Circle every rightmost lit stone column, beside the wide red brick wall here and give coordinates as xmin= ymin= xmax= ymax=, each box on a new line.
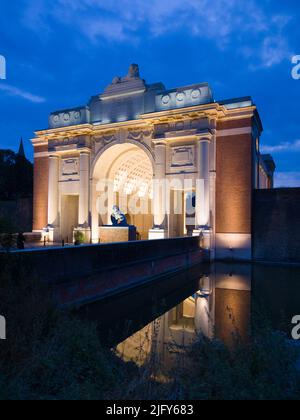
xmin=194 ymin=138 xmax=210 ymax=248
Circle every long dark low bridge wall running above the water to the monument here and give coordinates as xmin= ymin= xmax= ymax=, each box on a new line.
xmin=0 ymin=237 xmax=204 ymax=304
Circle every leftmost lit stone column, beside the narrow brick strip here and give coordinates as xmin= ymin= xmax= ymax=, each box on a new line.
xmin=48 ymin=155 xmax=59 ymax=228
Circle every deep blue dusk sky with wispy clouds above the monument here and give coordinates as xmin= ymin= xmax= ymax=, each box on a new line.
xmin=0 ymin=0 xmax=300 ymax=186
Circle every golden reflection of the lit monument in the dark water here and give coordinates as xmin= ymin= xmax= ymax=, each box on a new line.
xmin=117 ymin=264 xmax=251 ymax=368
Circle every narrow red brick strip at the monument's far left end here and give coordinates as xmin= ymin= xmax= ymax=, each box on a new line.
xmin=33 ymin=157 xmax=49 ymax=230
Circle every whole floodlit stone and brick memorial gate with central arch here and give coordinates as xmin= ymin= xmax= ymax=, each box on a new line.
xmin=33 ymin=65 xmax=274 ymax=258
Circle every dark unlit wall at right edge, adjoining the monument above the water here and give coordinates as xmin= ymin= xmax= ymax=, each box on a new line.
xmin=253 ymin=188 xmax=300 ymax=262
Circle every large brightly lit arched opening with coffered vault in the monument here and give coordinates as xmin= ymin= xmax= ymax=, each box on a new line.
xmin=92 ymin=143 xmax=153 ymax=242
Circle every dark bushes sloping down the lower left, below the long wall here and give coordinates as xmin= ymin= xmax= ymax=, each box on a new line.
xmin=0 ymin=255 xmax=131 ymax=400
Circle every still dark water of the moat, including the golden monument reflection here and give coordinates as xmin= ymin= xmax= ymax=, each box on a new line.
xmin=79 ymin=263 xmax=300 ymax=366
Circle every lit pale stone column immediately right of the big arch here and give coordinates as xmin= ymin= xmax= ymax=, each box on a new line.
xmin=149 ymin=142 xmax=167 ymax=239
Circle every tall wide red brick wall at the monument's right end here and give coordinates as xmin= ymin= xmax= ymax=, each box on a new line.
xmin=216 ymin=120 xmax=252 ymax=234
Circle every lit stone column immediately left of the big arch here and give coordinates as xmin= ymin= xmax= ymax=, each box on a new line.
xmin=78 ymin=152 xmax=90 ymax=228
